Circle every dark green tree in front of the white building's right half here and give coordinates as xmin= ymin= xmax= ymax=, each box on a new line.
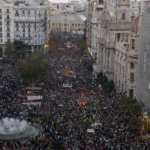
xmin=14 ymin=40 xmax=28 ymax=59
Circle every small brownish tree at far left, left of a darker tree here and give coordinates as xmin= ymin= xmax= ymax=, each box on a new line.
xmin=4 ymin=40 xmax=14 ymax=57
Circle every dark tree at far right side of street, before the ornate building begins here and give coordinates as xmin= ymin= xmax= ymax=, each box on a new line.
xmin=75 ymin=38 xmax=87 ymax=55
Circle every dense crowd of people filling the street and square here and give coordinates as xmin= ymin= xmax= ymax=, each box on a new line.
xmin=0 ymin=33 xmax=150 ymax=150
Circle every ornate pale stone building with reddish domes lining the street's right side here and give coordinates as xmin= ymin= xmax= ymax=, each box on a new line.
xmin=91 ymin=0 xmax=144 ymax=98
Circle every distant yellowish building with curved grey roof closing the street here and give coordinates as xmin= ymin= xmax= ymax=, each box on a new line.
xmin=52 ymin=12 xmax=86 ymax=32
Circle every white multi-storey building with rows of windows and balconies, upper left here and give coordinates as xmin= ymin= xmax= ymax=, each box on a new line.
xmin=0 ymin=0 xmax=51 ymax=55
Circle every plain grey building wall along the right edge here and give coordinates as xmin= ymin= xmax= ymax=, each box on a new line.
xmin=137 ymin=1 xmax=150 ymax=111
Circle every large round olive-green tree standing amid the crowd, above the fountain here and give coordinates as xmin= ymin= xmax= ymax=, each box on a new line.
xmin=16 ymin=53 xmax=49 ymax=82
